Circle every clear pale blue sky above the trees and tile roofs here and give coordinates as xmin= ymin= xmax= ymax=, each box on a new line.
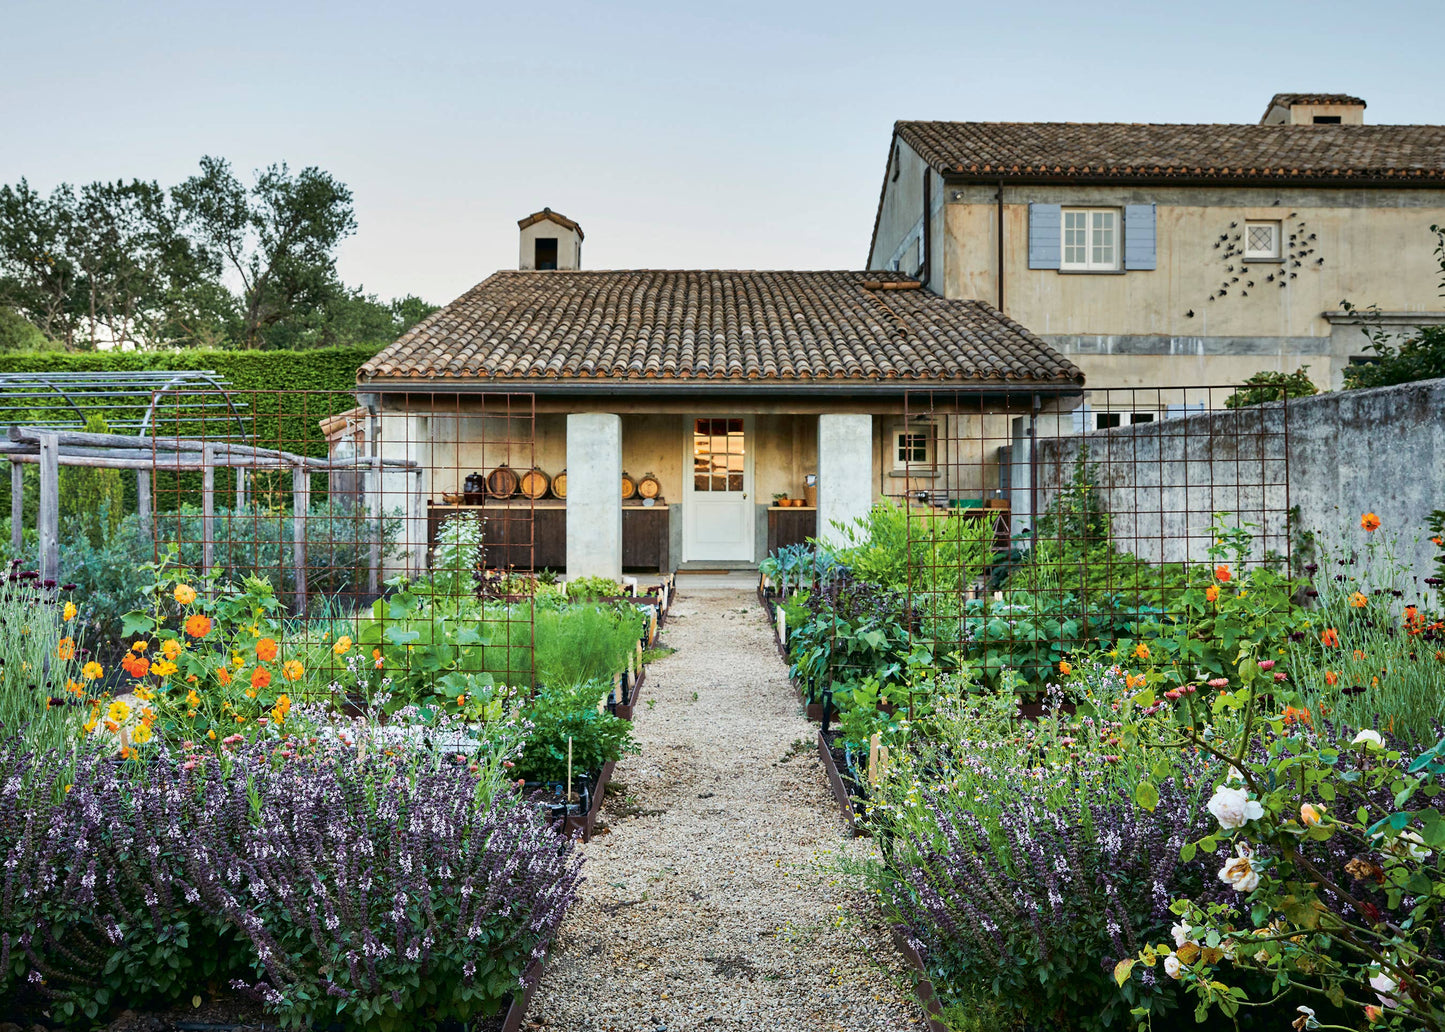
xmin=0 ymin=0 xmax=1445 ymax=304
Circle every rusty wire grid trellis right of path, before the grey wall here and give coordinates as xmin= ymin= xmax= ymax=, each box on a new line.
xmin=881 ymin=386 xmax=1290 ymax=692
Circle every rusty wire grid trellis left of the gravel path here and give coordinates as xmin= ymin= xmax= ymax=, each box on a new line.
xmin=150 ymin=390 xmax=535 ymax=705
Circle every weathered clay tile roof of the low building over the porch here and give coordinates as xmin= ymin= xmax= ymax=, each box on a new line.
xmin=357 ymin=270 xmax=1082 ymax=387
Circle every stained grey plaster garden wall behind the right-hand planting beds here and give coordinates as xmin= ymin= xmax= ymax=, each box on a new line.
xmin=1039 ymin=380 xmax=1445 ymax=578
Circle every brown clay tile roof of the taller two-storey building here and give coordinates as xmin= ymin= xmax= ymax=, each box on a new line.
xmin=894 ymin=121 xmax=1445 ymax=186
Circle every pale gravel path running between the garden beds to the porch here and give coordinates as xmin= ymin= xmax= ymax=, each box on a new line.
xmin=527 ymin=578 xmax=922 ymax=1032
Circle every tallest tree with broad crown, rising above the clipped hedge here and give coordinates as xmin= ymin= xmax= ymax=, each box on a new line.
xmin=172 ymin=156 xmax=355 ymax=348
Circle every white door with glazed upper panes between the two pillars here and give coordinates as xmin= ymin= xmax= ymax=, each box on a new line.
xmin=682 ymin=416 xmax=756 ymax=562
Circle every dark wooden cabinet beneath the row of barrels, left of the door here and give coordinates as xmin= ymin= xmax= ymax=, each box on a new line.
xmin=426 ymin=499 xmax=672 ymax=572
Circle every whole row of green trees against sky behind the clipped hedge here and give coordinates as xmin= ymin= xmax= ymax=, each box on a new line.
xmin=0 ymin=156 xmax=435 ymax=350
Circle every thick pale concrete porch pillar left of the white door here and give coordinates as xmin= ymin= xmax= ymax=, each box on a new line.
xmin=566 ymin=412 xmax=623 ymax=578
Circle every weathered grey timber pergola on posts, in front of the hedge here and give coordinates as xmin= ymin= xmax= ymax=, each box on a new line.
xmin=0 ymin=426 xmax=423 ymax=611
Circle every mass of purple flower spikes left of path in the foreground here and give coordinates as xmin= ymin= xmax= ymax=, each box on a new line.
xmin=0 ymin=741 xmax=581 ymax=1028
